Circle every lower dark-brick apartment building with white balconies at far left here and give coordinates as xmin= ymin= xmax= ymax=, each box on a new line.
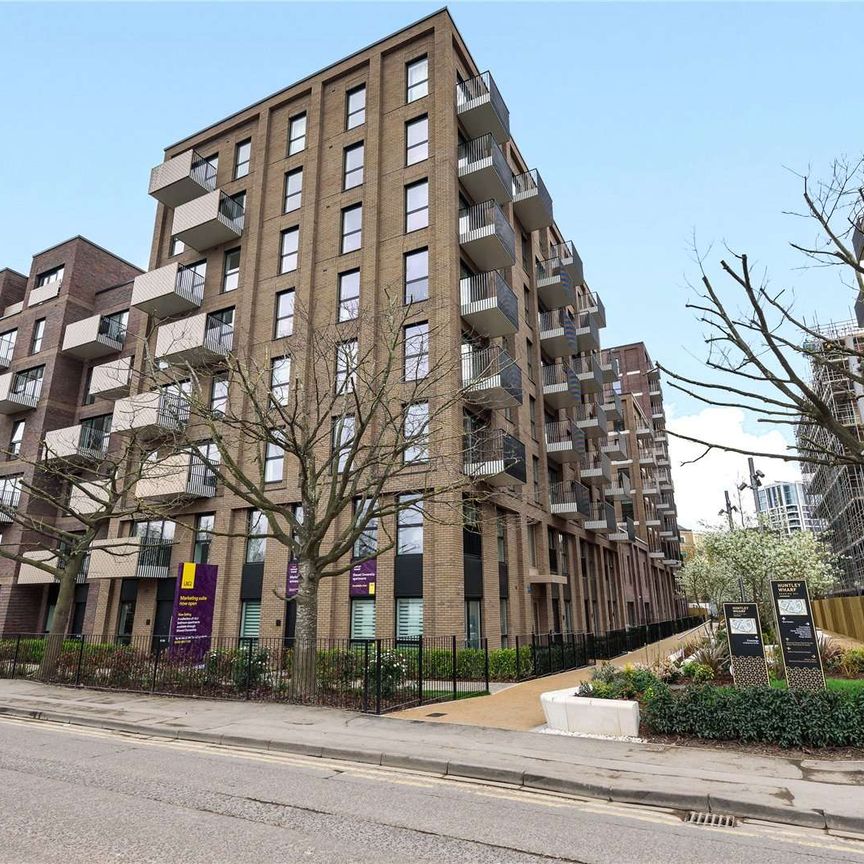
xmin=0 ymin=237 xmax=146 ymax=633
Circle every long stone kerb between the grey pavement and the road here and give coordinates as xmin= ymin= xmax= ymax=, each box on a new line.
xmin=0 ymin=705 xmax=852 ymax=833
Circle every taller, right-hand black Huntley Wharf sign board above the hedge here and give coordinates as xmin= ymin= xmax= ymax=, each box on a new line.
xmin=771 ymin=579 xmax=825 ymax=690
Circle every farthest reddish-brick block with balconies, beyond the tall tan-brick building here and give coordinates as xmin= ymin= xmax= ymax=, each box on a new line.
xmin=603 ymin=342 xmax=686 ymax=624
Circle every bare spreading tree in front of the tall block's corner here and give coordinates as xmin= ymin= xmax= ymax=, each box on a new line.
xmin=158 ymin=296 xmax=512 ymax=695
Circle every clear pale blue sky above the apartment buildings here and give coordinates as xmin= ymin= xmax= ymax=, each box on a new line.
xmin=0 ymin=3 xmax=864 ymax=520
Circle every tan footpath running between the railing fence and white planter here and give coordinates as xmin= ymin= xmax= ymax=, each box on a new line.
xmin=398 ymin=626 xmax=704 ymax=731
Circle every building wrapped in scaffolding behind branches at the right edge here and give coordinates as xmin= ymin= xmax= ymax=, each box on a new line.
xmin=798 ymin=320 xmax=864 ymax=589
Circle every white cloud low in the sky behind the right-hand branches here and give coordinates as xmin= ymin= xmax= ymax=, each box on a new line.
xmin=666 ymin=404 xmax=801 ymax=528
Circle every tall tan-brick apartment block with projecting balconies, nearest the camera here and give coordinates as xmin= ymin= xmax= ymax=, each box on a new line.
xmin=3 ymin=10 xmax=680 ymax=646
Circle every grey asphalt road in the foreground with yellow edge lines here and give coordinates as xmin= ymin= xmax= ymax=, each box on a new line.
xmin=0 ymin=718 xmax=864 ymax=864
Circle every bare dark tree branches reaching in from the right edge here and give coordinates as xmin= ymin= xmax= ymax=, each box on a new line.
xmin=659 ymin=160 xmax=864 ymax=465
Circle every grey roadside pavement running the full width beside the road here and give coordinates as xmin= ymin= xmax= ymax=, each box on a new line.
xmin=0 ymin=680 xmax=864 ymax=839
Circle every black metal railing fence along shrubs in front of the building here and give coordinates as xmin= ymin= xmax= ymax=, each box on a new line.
xmin=0 ymin=618 xmax=702 ymax=714
